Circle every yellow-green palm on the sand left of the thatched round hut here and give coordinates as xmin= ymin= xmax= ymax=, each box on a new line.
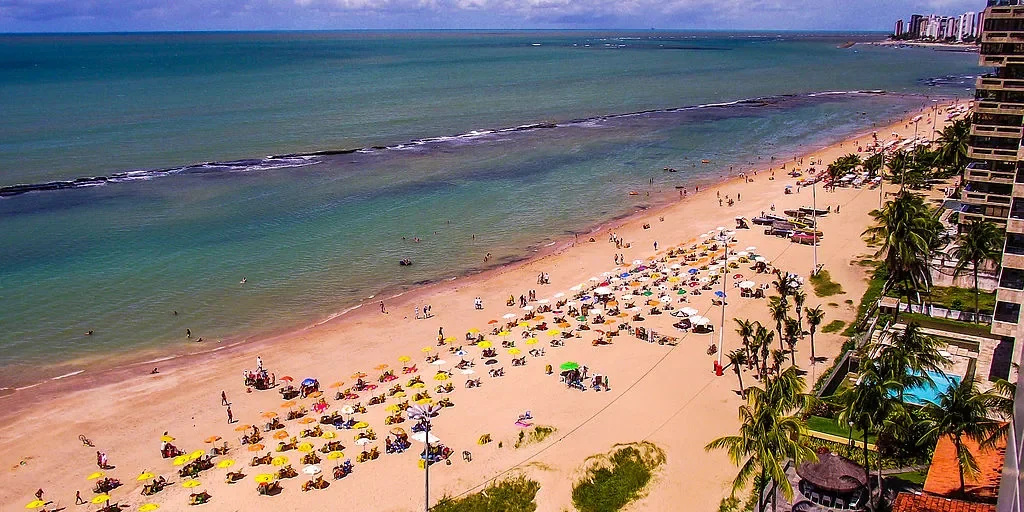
xmin=705 ymin=369 xmax=815 ymax=512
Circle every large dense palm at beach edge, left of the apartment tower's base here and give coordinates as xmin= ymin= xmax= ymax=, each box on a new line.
xmin=863 ymin=191 xmax=942 ymax=299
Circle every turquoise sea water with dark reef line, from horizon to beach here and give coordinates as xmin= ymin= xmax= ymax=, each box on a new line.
xmin=0 ymin=32 xmax=980 ymax=388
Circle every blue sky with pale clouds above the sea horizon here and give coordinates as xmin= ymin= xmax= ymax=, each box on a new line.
xmin=0 ymin=0 xmax=985 ymax=32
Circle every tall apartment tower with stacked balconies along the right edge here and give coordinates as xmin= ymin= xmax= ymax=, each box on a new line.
xmin=974 ymin=0 xmax=1024 ymax=512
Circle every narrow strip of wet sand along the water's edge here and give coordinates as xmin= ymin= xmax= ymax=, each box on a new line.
xmin=0 ymin=95 xmax=954 ymax=415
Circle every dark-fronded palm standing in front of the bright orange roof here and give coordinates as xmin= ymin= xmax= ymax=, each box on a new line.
xmin=921 ymin=379 xmax=996 ymax=494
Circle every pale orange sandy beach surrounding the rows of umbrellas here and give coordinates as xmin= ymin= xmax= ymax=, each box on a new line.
xmin=0 ymin=101 xmax=958 ymax=511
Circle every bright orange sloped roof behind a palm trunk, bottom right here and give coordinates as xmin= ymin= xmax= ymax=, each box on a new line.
xmin=925 ymin=436 xmax=1007 ymax=499
